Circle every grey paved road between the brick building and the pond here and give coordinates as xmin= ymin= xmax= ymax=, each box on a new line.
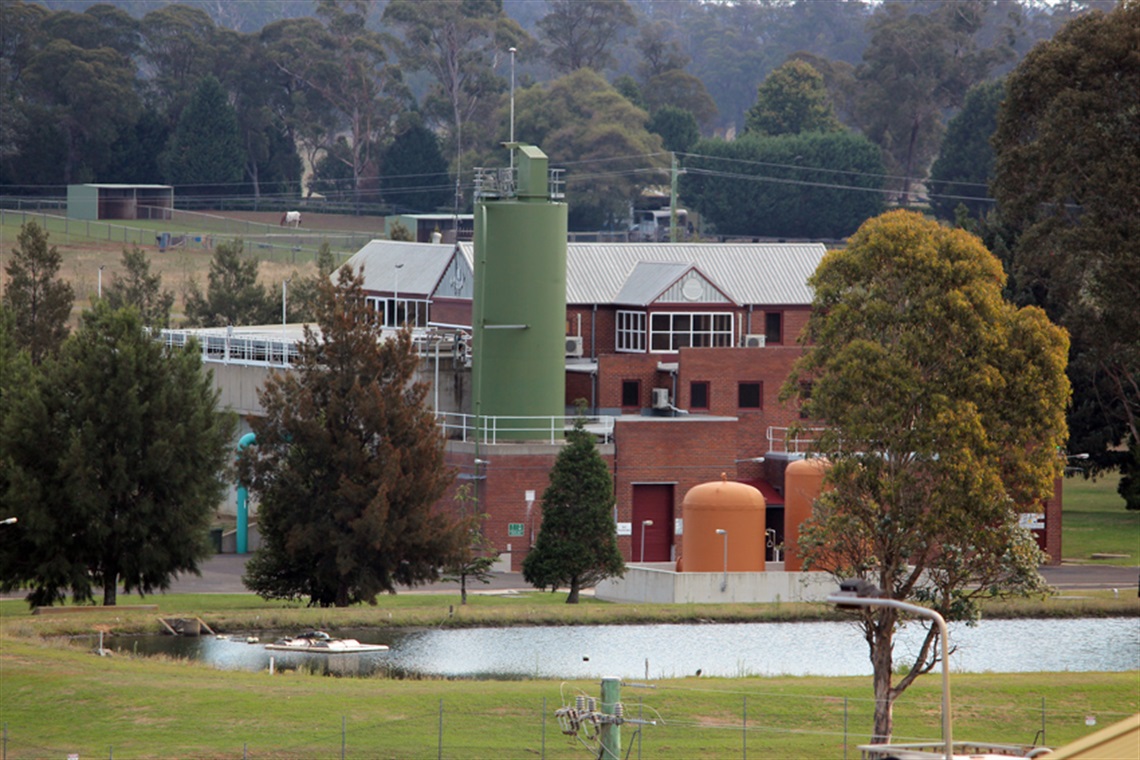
xmin=171 ymin=554 xmax=1140 ymax=594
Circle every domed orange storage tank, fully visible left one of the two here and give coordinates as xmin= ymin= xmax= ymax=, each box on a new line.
xmin=678 ymin=479 xmax=766 ymax=573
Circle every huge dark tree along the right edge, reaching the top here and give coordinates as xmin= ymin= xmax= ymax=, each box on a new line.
xmin=992 ymin=1 xmax=1140 ymax=508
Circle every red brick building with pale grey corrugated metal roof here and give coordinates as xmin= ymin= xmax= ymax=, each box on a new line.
xmin=330 ymin=240 xmax=1060 ymax=570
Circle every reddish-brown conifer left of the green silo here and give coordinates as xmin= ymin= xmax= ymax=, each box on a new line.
xmin=241 ymin=268 xmax=470 ymax=607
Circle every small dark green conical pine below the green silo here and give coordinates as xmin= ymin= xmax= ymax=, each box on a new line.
xmin=522 ymin=416 xmax=625 ymax=604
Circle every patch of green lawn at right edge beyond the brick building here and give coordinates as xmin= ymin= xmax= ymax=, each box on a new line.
xmin=1061 ymin=474 xmax=1140 ymax=565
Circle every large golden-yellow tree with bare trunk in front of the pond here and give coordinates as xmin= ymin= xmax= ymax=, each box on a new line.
xmin=782 ymin=211 xmax=1069 ymax=742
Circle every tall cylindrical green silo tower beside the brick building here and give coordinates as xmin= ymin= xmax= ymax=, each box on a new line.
xmin=472 ymin=145 xmax=567 ymax=440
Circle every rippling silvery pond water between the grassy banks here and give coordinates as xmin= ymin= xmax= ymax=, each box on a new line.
xmin=105 ymin=618 xmax=1140 ymax=679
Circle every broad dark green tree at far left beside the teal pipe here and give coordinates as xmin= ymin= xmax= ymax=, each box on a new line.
xmin=0 ymin=301 xmax=234 ymax=606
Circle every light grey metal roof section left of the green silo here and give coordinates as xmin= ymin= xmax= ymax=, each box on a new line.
xmin=344 ymin=240 xmax=455 ymax=299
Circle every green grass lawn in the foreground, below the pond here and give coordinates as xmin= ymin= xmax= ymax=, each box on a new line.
xmin=0 ymin=637 xmax=1140 ymax=760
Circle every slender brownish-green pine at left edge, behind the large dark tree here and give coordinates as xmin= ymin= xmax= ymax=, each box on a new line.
xmin=3 ymin=222 xmax=75 ymax=365
